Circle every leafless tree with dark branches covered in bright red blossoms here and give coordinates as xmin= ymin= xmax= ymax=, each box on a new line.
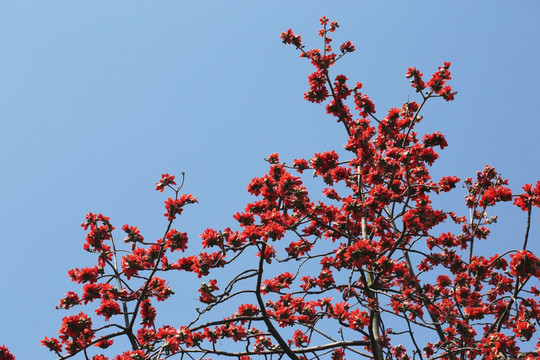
xmin=5 ymin=17 xmax=540 ymax=360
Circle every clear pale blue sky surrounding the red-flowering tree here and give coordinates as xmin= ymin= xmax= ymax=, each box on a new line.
xmin=0 ymin=0 xmax=540 ymax=359
